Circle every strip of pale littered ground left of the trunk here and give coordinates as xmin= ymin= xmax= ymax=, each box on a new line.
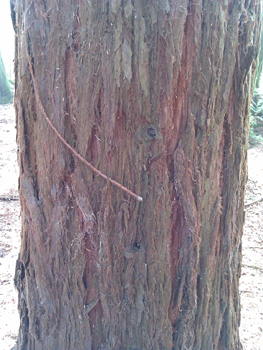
xmin=0 ymin=105 xmax=20 ymax=350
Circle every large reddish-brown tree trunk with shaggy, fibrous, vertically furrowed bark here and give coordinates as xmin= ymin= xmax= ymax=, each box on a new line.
xmin=15 ymin=0 xmax=260 ymax=350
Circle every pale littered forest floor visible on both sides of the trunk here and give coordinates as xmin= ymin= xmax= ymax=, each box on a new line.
xmin=0 ymin=105 xmax=263 ymax=350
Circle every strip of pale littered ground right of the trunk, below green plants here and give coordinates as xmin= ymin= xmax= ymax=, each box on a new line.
xmin=240 ymin=144 xmax=263 ymax=350
